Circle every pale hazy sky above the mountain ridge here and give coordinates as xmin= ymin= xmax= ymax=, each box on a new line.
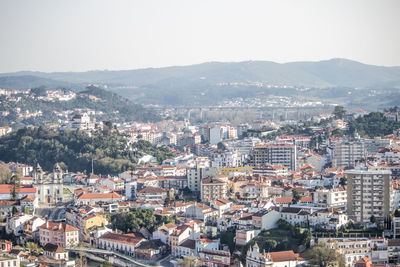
xmin=0 ymin=0 xmax=400 ymax=73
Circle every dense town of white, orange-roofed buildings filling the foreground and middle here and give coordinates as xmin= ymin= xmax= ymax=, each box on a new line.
xmin=0 ymin=104 xmax=400 ymax=267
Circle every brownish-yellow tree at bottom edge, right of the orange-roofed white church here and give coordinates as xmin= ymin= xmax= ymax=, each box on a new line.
xmin=305 ymin=243 xmax=345 ymax=267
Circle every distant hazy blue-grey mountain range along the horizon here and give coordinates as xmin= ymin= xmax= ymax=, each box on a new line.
xmin=0 ymin=59 xmax=400 ymax=104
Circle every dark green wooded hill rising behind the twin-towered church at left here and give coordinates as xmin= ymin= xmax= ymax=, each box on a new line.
xmin=0 ymin=127 xmax=172 ymax=174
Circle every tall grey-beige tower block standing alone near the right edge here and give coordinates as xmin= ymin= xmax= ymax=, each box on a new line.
xmin=345 ymin=167 xmax=393 ymax=222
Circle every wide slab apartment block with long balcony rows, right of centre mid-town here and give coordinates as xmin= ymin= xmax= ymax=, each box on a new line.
xmin=252 ymin=144 xmax=297 ymax=171
